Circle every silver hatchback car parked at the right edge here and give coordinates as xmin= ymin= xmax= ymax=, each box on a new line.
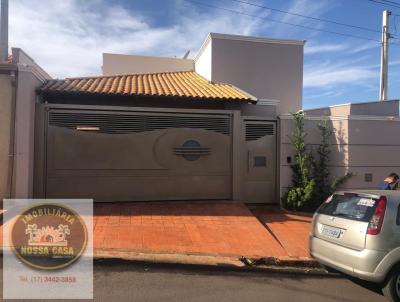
xmin=309 ymin=190 xmax=400 ymax=302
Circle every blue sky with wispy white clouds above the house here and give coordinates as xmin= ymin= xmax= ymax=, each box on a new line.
xmin=10 ymin=0 xmax=400 ymax=108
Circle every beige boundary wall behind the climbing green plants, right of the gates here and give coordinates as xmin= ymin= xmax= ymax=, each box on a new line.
xmin=280 ymin=116 xmax=400 ymax=196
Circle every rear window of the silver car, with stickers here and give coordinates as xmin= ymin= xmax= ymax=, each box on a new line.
xmin=317 ymin=194 xmax=377 ymax=222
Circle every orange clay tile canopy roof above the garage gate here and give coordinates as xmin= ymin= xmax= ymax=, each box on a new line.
xmin=39 ymin=71 xmax=256 ymax=102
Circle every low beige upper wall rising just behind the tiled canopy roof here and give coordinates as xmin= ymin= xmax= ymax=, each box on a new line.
xmin=102 ymin=53 xmax=194 ymax=75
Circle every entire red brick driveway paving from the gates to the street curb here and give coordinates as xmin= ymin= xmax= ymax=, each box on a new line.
xmin=0 ymin=201 xmax=311 ymax=259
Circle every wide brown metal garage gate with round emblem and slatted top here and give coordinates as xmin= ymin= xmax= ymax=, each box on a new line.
xmin=43 ymin=109 xmax=232 ymax=201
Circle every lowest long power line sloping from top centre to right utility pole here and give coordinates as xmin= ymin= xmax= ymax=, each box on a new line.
xmin=183 ymin=0 xmax=380 ymax=43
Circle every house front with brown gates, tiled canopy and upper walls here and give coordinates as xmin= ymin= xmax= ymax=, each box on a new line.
xmin=35 ymin=34 xmax=304 ymax=203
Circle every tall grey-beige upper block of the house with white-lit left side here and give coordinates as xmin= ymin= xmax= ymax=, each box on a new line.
xmin=195 ymin=34 xmax=304 ymax=114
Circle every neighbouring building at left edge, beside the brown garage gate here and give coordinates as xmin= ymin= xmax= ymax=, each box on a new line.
xmin=0 ymin=48 xmax=50 ymax=200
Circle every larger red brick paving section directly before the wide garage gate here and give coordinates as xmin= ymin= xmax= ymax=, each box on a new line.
xmin=94 ymin=202 xmax=287 ymax=257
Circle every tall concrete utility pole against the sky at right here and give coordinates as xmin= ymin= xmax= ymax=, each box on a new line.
xmin=379 ymin=10 xmax=391 ymax=101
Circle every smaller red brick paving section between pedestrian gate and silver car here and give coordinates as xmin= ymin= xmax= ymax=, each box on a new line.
xmin=250 ymin=206 xmax=312 ymax=257
